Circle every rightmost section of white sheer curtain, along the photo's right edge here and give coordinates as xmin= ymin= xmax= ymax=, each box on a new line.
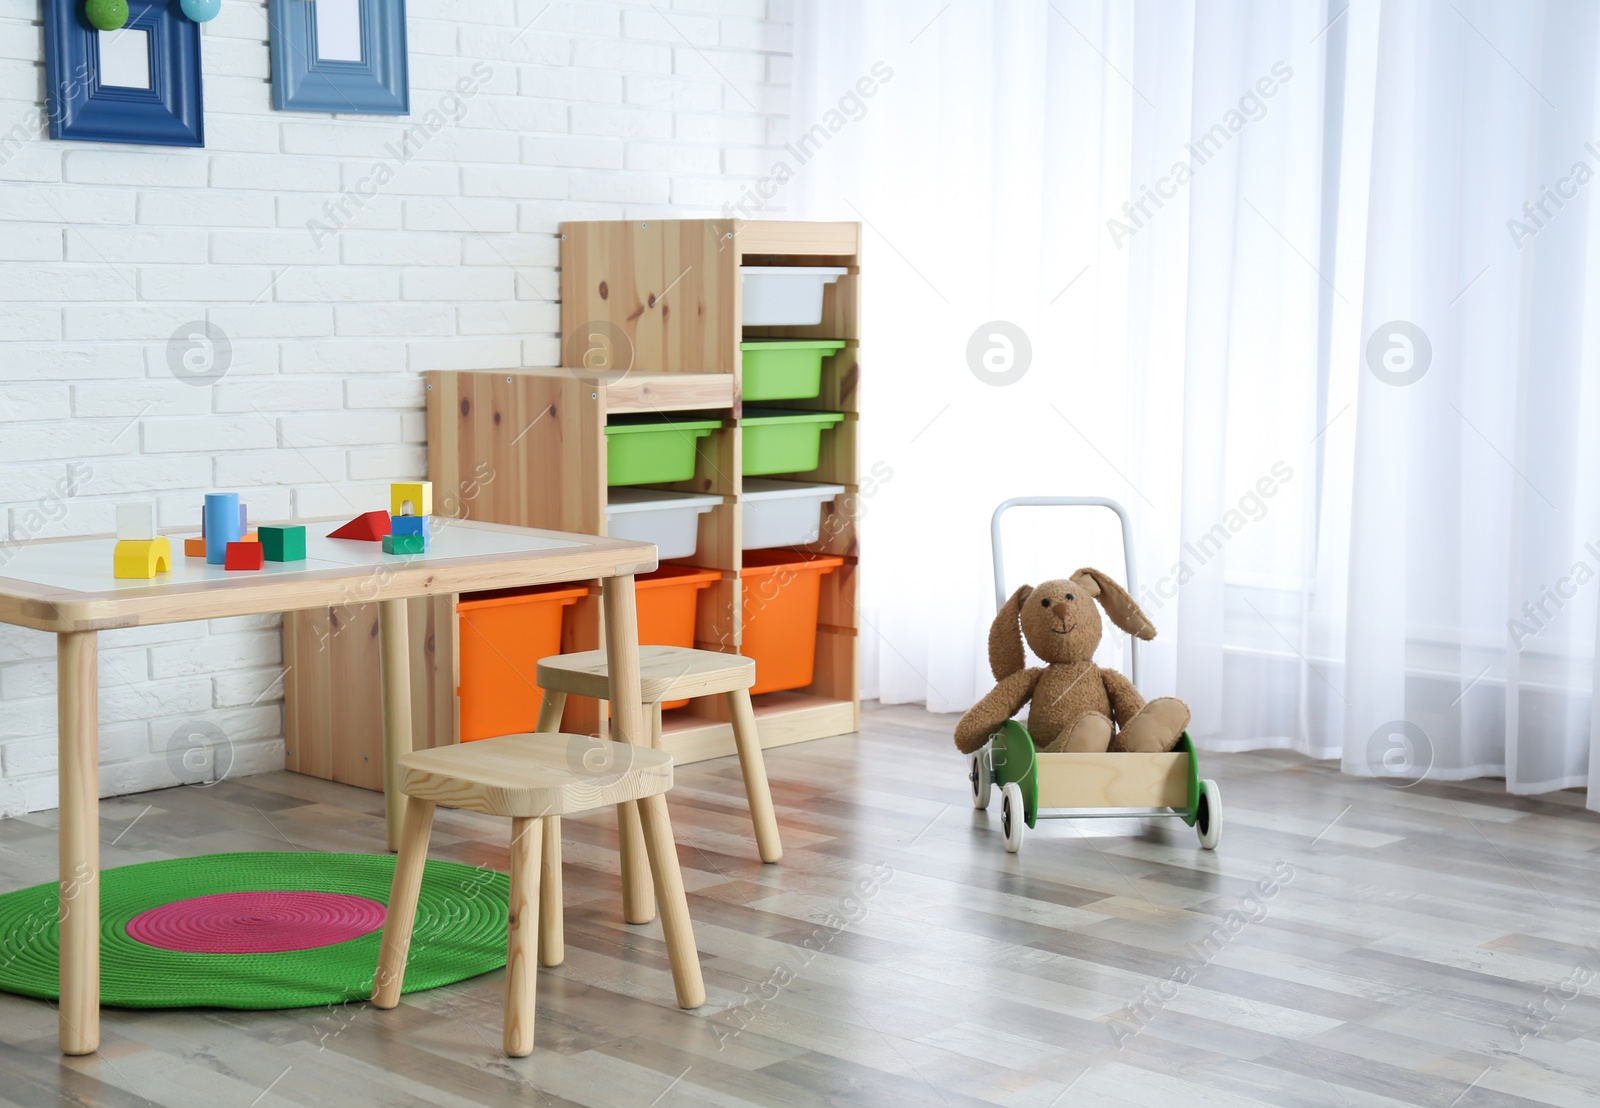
xmin=1342 ymin=3 xmax=1600 ymax=797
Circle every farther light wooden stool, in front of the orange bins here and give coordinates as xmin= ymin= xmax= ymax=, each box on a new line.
xmin=536 ymin=647 xmax=784 ymax=928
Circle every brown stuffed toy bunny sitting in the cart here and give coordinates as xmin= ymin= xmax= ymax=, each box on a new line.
xmin=955 ymin=568 xmax=1189 ymax=754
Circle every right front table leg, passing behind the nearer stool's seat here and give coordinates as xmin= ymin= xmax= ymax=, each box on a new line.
xmin=600 ymin=573 xmax=656 ymax=924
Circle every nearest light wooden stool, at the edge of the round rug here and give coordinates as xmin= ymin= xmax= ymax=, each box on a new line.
xmin=373 ymin=735 xmax=706 ymax=1058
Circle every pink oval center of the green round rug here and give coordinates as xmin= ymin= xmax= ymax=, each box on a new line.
xmin=128 ymin=892 xmax=384 ymax=954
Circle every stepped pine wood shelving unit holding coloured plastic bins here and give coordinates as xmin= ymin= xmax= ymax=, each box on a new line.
xmin=285 ymin=219 xmax=861 ymax=788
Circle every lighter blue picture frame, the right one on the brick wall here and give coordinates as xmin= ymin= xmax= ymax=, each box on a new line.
xmin=267 ymin=0 xmax=411 ymax=115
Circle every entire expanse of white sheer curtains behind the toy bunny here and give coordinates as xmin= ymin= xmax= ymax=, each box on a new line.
xmin=793 ymin=0 xmax=1600 ymax=807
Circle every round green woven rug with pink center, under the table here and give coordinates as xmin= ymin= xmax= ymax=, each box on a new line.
xmin=0 ymin=853 xmax=510 ymax=1009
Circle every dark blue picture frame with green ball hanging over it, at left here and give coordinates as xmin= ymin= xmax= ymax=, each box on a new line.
xmin=45 ymin=0 xmax=205 ymax=146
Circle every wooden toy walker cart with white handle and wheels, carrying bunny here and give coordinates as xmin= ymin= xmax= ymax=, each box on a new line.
xmin=968 ymin=496 xmax=1222 ymax=853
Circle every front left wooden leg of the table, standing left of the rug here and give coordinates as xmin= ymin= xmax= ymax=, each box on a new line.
xmin=56 ymin=631 xmax=99 ymax=1054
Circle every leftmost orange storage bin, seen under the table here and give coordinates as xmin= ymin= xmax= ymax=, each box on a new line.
xmin=456 ymin=584 xmax=589 ymax=743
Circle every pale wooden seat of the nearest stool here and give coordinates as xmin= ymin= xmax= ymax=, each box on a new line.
xmin=400 ymin=733 xmax=672 ymax=817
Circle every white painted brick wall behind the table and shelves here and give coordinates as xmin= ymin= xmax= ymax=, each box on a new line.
xmin=0 ymin=0 xmax=790 ymax=815
